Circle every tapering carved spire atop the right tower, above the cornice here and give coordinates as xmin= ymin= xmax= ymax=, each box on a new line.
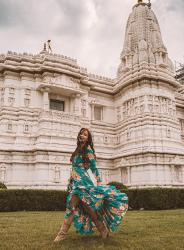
xmin=118 ymin=1 xmax=173 ymax=75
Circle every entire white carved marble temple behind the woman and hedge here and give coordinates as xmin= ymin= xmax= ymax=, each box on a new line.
xmin=0 ymin=1 xmax=184 ymax=189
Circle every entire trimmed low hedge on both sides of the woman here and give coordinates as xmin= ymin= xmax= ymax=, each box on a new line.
xmin=0 ymin=188 xmax=184 ymax=212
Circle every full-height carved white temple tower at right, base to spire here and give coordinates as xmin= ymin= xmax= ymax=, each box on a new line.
xmin=116 ymin=0 xmax=184 ymax=187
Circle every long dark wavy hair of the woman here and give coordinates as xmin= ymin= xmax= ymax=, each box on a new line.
xmin=70 ymin=128 xmax=96 ymax=163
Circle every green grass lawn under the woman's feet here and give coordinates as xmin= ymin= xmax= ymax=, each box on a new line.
xmin=0 ymin=210 xmax=184 ymax=250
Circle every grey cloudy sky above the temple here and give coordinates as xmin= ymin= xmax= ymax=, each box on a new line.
xmin=0 ymin=0 xmax=184 ymax=77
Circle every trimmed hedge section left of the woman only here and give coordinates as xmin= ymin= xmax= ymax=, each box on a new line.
xmin=0 ymin=189 xmax=67 ymax=212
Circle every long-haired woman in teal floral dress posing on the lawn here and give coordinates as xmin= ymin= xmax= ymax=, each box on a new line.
xmin=54 ymin=128 xmax=128 ymax=242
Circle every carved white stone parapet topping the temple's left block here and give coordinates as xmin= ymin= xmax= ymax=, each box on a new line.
xmin=0 ymin=51 xmax=87 ymax=79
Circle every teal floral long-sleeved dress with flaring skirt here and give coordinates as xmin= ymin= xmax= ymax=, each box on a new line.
xmin=64 ymin=146 xmax=128 ymax=234
